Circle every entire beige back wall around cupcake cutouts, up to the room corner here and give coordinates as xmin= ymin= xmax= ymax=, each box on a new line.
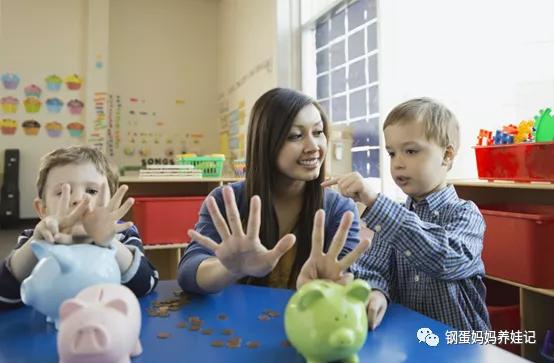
xmin=0 ymin=0 xmax=219 ymax=218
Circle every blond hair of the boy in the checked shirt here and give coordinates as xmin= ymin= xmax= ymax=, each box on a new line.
xmin=383 ymin=97 xmax=460 ymax=155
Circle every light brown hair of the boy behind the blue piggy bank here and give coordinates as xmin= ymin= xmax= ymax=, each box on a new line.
xmin=37 ymin=145 xmax=119 ymax=199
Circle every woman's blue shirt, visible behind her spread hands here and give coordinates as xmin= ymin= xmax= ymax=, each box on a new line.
xmin=177 ymin=181 xmax=360 ymax=294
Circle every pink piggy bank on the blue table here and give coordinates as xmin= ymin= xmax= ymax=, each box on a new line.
xmin=58 ymin=284 xmax=142 ymax=363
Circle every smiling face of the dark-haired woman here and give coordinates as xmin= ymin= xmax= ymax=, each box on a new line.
xmin=277 ymin=104 xmax=327 ymax=181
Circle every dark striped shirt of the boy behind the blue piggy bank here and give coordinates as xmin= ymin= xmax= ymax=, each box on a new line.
xmin=0 ymin=226 xmax=159 ymax=310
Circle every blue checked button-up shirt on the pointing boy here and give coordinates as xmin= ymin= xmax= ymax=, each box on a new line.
xmin=352 ymin=185 xmax=490 ymax=331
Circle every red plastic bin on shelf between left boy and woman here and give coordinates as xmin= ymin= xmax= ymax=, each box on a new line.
xmin=133 ymin=197 xmax=205 ymax=245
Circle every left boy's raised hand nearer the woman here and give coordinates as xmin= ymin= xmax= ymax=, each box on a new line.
xmin=82 ymin=184 xmax=135 ymax=246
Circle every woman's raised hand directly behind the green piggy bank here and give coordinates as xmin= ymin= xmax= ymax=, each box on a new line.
xmin=296 ymin=209 xmax=369 ymax=289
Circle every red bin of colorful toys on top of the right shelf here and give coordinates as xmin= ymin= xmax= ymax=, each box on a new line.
xmin=475 ymin=142 xmax=554 ymax=182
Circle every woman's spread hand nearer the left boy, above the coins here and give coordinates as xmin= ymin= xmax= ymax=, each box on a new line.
xmin=188 ymin=186 xmax=296 ymax=277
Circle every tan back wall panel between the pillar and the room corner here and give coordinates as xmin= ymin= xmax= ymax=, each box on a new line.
xmin=109 ymin=0 xmax=219 ymax=166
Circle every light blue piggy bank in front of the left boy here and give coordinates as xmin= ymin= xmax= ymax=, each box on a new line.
xmin=21 ymin=241 xmax=121 ymax=328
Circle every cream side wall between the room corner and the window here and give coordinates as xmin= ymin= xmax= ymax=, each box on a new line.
xmin=217 ymin=0 xmax=277 ymax=158
